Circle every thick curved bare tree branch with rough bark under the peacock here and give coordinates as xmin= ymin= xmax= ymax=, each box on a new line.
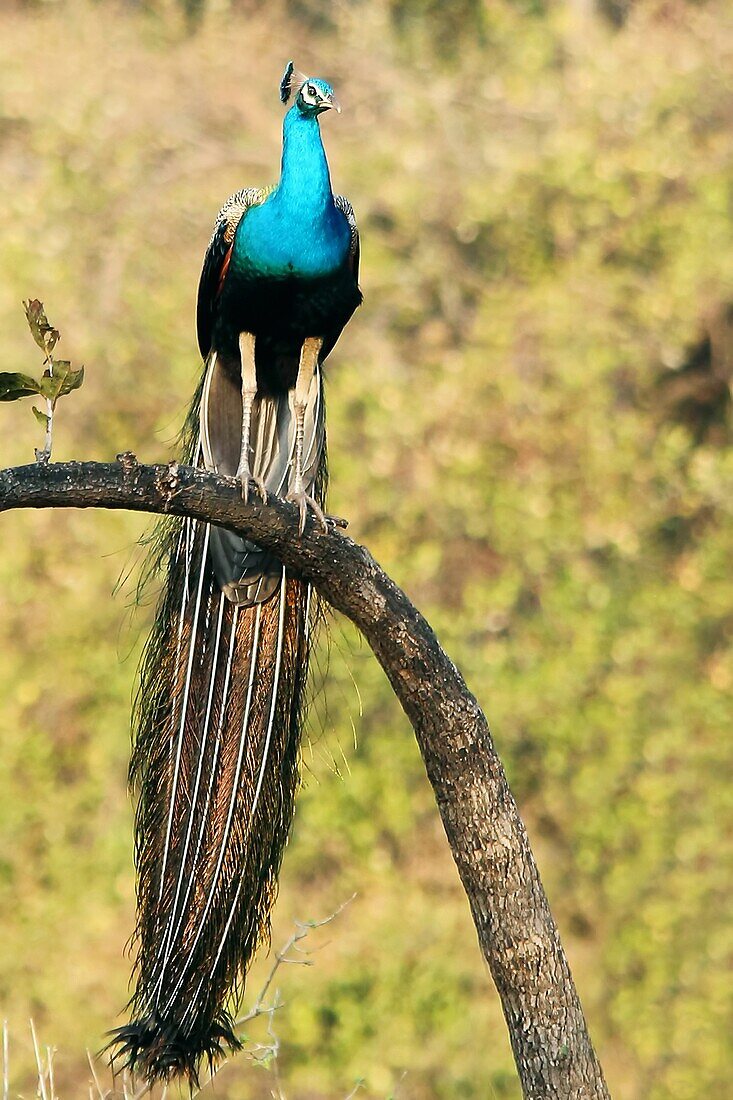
xmin=0 ymin=454 xmax=609 ymax=1100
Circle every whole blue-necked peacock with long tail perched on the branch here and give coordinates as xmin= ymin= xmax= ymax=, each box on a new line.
xmin=111 ymin=62 xmax=361 ymax=1085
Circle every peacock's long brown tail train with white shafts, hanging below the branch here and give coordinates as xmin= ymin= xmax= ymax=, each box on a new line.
xmin=111 ymin=371 xmax=325 ymax=1084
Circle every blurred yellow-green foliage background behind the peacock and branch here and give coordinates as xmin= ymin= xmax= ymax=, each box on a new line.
xmin=0 ymin=0 xmax=733 ymax=1100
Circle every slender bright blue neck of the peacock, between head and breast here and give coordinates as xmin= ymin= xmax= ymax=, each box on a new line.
xmin=272 ymin=103 xmax=333 ymax=212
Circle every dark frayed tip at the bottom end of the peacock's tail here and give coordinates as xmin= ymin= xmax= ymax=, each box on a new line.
xmin=103 ymin=1015 xmax=242 ymax=1088
